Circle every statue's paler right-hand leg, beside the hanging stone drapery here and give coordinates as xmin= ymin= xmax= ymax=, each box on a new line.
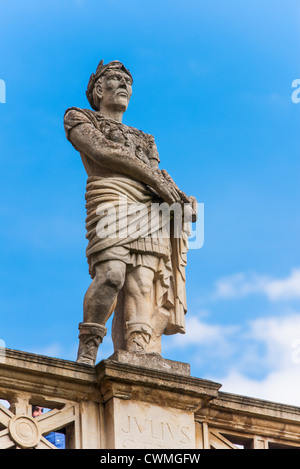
xmin=124 ymin=267 xmax=154 ymax=352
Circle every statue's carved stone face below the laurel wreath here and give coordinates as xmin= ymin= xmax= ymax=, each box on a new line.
xmin=96 ymin=70 xmax=132 ymax=112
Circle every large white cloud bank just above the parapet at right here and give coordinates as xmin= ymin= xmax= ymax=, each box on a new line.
xmin=163 ymin=312 xmax=300 ymax=406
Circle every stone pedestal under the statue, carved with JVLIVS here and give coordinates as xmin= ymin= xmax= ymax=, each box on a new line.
xmin=98 ymin=352 xmax=220 ymax=449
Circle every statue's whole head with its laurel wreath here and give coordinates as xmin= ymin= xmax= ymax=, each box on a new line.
xmin=86 ymin=60 xmax=133 ymax=112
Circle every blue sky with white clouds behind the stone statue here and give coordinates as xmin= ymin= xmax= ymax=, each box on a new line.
xmin=0 ymin=0 xmax=300 ymax=406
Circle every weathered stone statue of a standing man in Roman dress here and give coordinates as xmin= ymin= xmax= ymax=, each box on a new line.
xmin=64 ymin=60 xmax=197 ymax=365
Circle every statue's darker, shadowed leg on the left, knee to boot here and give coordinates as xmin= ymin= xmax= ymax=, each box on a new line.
xmin=77 ymin=260 xmax=126 ymax=365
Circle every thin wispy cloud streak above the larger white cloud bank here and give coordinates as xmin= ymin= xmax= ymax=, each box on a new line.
xmin=214 ymin=269 xmax=300 ymax=301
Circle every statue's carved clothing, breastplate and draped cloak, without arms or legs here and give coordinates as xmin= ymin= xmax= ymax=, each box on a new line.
xmin=64 ymin=108 xmax=189 ymax=334
